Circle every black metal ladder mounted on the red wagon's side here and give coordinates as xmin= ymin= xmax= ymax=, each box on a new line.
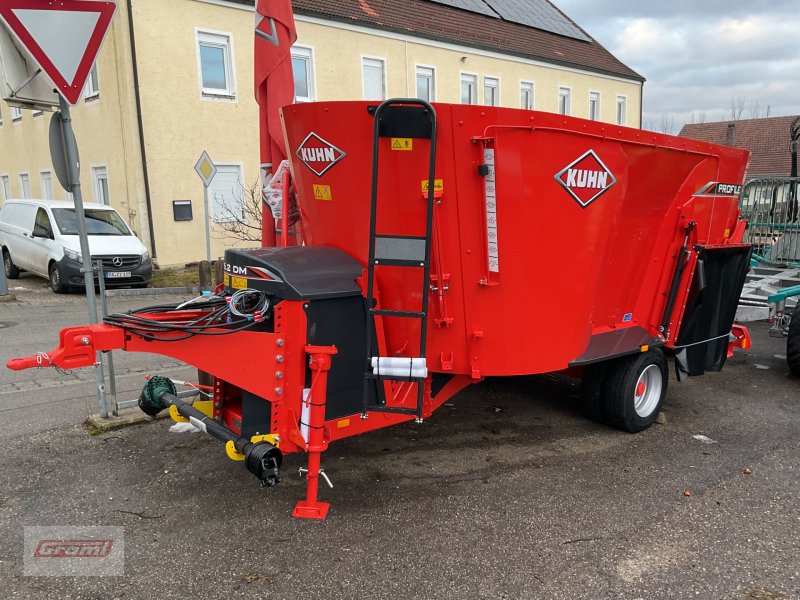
xmin=361 ymin=98 xmax=436 ymax=422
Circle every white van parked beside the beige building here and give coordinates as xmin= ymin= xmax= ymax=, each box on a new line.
xmin=0 ymin=200 xmax=153 ymax=293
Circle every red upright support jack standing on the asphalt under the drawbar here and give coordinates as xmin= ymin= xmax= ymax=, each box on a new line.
xmin=292 ymin=346 xmax=337 ymax=520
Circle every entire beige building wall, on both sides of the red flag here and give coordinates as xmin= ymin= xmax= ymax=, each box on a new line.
xmin=0 ymin=0 xmax=641 ymax=265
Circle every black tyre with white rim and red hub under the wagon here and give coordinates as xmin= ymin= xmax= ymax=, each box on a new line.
xmin=603 ymin=349 xmax=668 ymax=433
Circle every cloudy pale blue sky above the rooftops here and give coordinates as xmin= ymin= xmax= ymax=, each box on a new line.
xmin=553 ymin=0 xmax=800 ymax=134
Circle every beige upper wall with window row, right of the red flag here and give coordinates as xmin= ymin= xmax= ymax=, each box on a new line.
xmin=296 ymin=16 xmax=642 ymax=127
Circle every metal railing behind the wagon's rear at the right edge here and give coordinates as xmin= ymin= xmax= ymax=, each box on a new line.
xmin=739 ymin=177 xmax=800 ymax=266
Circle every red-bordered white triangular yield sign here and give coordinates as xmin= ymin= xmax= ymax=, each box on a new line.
xmin=0 ymin=0 xmax=117 ymax=104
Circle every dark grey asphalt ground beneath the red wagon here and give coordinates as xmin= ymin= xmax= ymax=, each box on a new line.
xmin=0 ymin=288 xmax=800 ymax=600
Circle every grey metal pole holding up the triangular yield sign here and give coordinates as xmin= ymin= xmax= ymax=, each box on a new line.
xmin=58 ymin=94 xmax=108 ymax=419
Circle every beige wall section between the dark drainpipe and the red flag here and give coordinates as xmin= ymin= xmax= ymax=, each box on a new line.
xmin=134 ymin=0 xmax=259 ymax=264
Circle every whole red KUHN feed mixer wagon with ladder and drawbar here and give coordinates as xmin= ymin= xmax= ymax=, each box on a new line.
xmin=8 ymin=99 xmax=751 ymax=518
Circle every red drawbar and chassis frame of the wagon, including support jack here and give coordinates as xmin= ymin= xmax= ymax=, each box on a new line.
xmin=7 ymin=300 xmax=480 ymax=519
